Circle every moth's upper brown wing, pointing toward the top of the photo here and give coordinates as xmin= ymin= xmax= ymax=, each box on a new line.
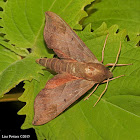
xmin=44 ymin=12 xmax=100 ymax=63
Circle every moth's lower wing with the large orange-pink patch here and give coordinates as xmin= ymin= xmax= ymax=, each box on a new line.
xmin=33 ymin=74 xmax=95 ymax=125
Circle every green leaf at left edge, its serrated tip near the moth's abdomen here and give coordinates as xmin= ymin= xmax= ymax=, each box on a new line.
xmin=0 ymin=56 xmax=42 ymax=97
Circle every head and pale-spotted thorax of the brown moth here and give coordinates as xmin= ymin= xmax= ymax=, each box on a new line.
xmin=85 ymin=63 xmax=113 ymax=83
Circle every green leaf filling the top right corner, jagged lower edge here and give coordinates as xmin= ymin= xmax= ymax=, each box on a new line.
xmin=84 ymin=0 xmax=140 ymax=42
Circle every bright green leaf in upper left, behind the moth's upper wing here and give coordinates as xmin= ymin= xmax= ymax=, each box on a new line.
xmin=0 ymin=0 xmax=93 ymax=57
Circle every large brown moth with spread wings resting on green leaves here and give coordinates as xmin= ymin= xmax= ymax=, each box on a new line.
xmin=33 ymin=12 xmax=113 ymax=125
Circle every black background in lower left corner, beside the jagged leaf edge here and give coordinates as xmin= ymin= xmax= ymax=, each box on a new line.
xmin=0 ymin=83 xmax=37 ymax=140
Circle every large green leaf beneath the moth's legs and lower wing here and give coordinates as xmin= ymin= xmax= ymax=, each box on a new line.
xmin=19 ymin=23 xmax=140 ymax=140
